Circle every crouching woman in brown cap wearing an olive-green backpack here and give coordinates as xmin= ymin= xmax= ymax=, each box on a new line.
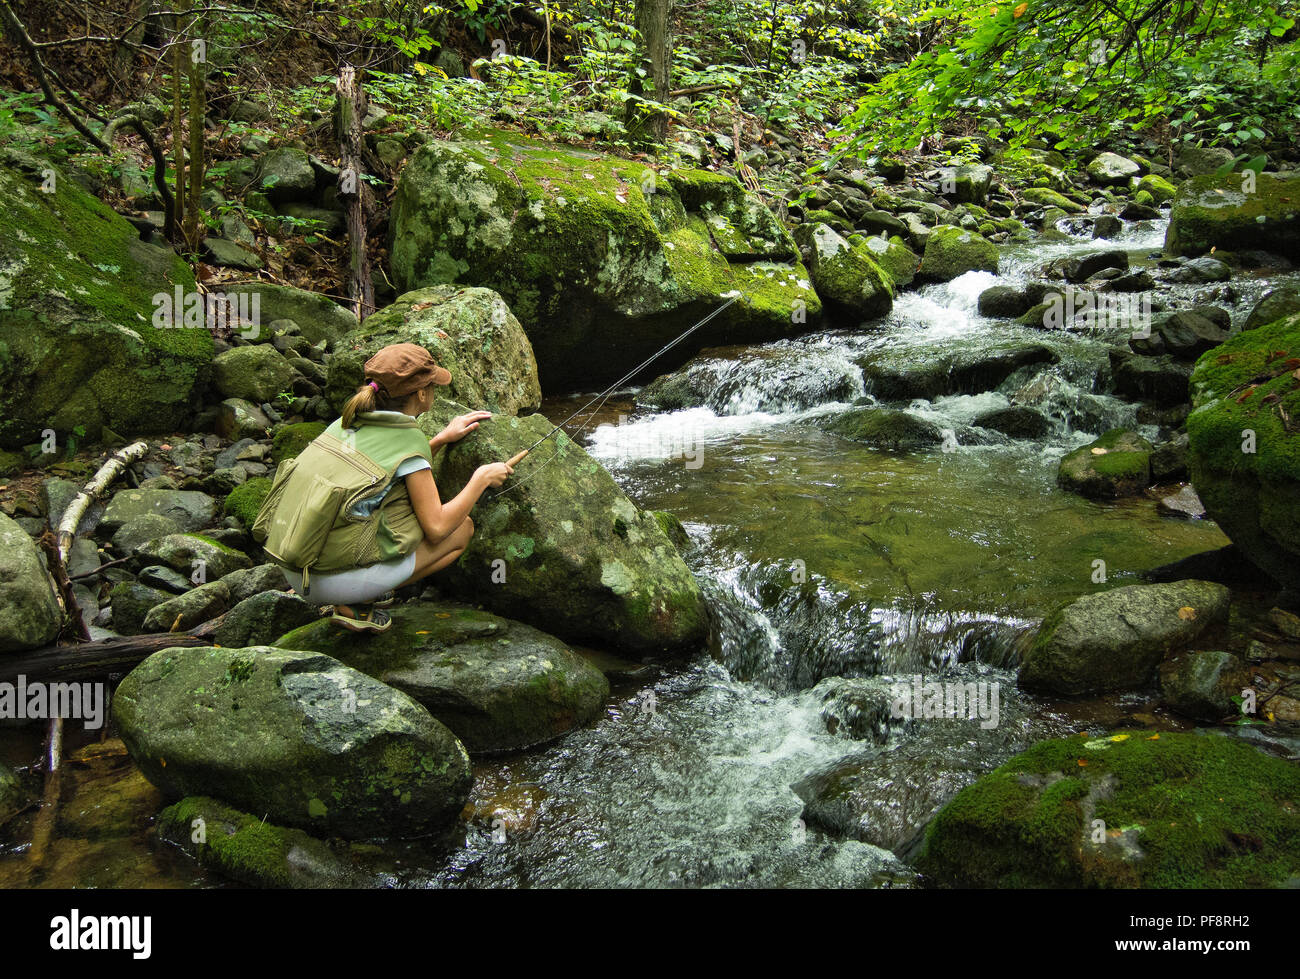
xmin=252 ymin=343 xmax=514 ymax=632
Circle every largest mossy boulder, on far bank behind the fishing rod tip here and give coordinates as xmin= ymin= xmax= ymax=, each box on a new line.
xmin=390 ymin=130 xmax=822 ymax=390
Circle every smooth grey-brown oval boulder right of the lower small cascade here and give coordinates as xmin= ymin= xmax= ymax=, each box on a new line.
xmin=1018 ymin=581 xmax=1229 ymax=697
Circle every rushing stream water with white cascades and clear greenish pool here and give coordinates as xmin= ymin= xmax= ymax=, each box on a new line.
xmin=5 ymin=222 xmax=1284 ymax=887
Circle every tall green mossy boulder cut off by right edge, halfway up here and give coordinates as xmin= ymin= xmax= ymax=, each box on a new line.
xmin=1187 ymin=313 xmax=1300 ymax=588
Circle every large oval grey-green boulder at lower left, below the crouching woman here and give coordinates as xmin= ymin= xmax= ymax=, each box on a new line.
xmin=113 ymin=646 xmax=472 ymax=839
